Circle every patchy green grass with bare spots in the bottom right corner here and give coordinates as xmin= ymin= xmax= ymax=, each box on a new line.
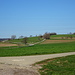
xmin=39 ymin=55 xmax=75 ymax=75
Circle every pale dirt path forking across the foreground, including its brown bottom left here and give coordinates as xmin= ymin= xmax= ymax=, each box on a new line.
xmin=0 ymin=52 xmax=75 ymax=75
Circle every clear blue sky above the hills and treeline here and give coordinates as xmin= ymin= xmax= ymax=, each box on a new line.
xmin=0 ymin=0 xmax=75 ymax=38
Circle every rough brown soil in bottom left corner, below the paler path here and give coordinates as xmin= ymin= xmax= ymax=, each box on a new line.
xmin=0 ymin=64 xmax=40 ymax=75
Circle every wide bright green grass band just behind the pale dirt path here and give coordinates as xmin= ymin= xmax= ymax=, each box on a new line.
xmin=0 ymin=42 xmax=75 ymax=57
